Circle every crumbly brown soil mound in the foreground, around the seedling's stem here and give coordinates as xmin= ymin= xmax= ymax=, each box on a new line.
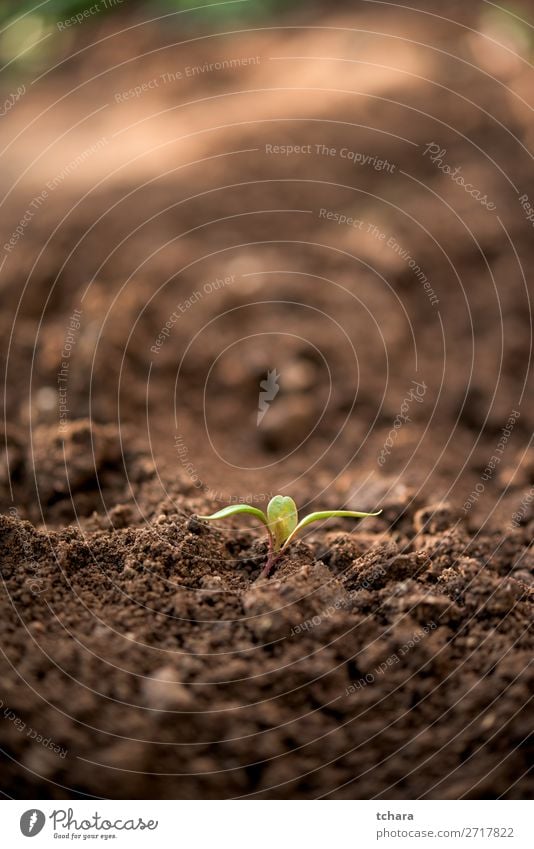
xmin=0 ymin=480 xmax=534 ymax=798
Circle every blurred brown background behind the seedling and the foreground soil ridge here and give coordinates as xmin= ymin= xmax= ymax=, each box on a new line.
xmin=0 ymin=0 xmax=534 ymax=522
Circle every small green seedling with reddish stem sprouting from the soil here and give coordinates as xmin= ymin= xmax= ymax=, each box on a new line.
xmin=198 ymin=495 xmax=382 ymax=578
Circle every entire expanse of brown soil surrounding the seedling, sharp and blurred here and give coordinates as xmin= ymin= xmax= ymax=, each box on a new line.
xmin=0 ymin=2 xmax=534 ymax=799
